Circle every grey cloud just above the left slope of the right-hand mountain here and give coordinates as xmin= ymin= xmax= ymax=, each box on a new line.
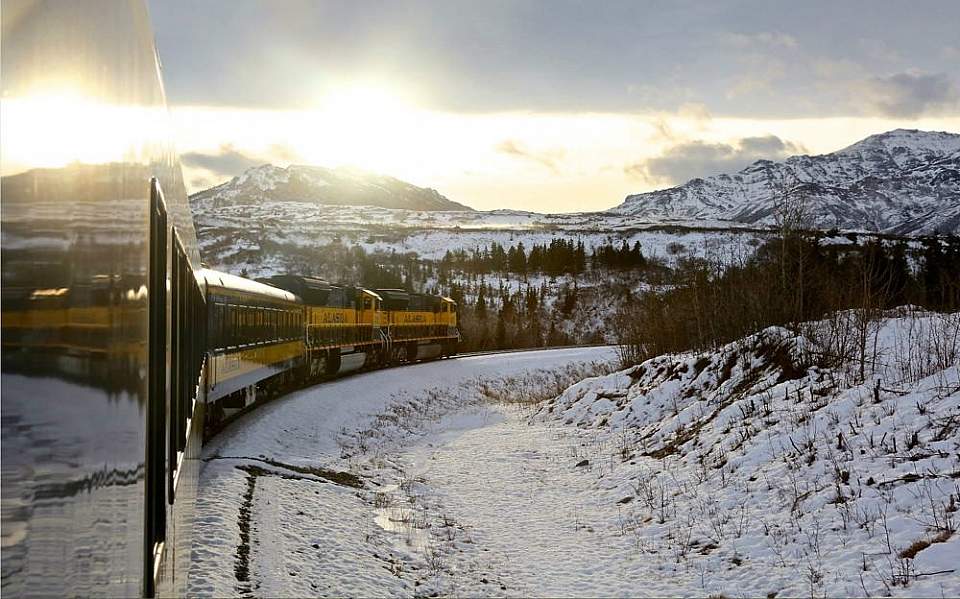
xmin=624 ymin=135 xmax=805 ymax=185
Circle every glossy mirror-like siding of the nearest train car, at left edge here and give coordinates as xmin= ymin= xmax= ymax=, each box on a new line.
xmin=0 ymin=0 xmax=203 ymax=596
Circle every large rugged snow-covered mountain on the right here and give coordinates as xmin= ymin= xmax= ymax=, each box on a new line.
xmin=610 ymin=129 xmax=960 ymax=234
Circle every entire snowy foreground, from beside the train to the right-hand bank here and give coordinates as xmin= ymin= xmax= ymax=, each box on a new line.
xmin=191 ymin=311 xmax=960 ymax=597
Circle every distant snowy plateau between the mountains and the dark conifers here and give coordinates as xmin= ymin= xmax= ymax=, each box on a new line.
xmin=194 ymin=202 xmax=771 ymax=276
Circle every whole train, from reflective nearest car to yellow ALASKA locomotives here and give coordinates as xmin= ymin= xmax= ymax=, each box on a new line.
xmin=0 ymin=0 xmax=460 ymax=597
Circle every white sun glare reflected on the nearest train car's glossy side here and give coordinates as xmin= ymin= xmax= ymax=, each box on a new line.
xmin=0 ymin=90 xmax=165 ymax=175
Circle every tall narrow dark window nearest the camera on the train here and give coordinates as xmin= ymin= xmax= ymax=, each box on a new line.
xmin=144 ymin=179 xmax=167 ymax=584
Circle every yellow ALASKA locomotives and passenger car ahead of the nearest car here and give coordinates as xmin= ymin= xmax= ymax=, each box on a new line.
xmin=199 ymin=269 xmax=461 ymax=436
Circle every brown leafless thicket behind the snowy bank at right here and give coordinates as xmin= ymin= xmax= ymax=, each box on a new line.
xmin=617 ymin=231 xmax=960 ymax=363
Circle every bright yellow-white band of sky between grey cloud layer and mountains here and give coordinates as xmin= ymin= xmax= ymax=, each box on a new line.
xmin=172 ymin=102 xmax=960 ymax=213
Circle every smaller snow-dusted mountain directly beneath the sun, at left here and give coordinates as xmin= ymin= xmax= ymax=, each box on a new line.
xmin=190 ymin=164 xmax=473 ymax=211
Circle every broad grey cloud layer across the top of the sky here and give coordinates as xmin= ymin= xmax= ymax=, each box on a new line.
xmin=148 ymin=0 xmax=960 ymax=118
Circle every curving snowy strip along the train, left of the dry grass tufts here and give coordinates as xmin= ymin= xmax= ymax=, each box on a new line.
xmin=190 ymin=348 xmax=614 ymax=596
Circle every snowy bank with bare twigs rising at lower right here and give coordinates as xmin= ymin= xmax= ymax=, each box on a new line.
xmin=540 ymin=310 xmax=960 ymax=597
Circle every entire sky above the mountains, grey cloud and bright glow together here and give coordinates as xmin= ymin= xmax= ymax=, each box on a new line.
xmin=148 ymin=0 xmax=960 ymax=212
